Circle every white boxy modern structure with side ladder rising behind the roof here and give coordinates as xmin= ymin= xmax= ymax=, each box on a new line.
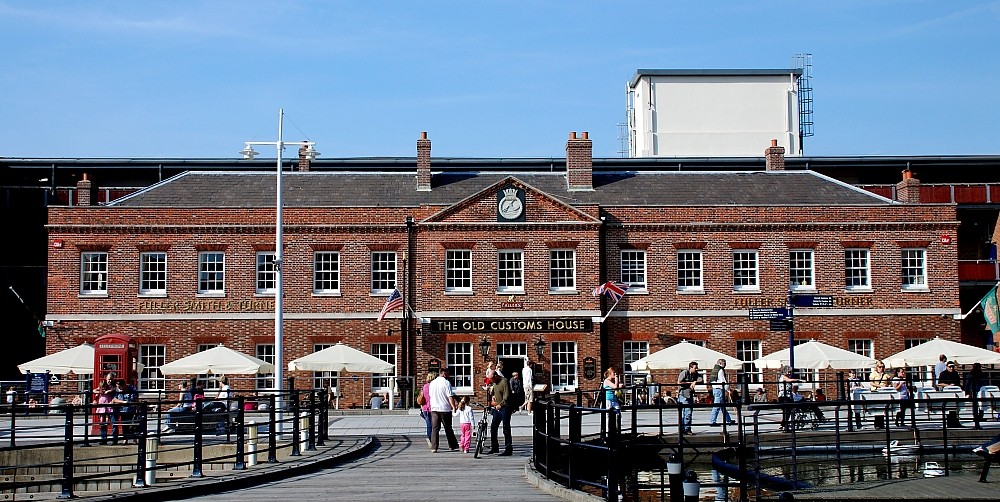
xmin=626 ymin=67 xmax=812 ymax=157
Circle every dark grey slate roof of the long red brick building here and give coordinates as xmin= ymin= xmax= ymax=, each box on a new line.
xmin=109 ymin=171 xmax=893 ymax=208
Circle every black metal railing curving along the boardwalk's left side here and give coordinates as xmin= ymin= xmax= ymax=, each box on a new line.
xmin=0 ymin=384 xmax=329 ymax=498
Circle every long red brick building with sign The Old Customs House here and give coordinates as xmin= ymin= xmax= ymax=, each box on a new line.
xmin=46 ymin=133 xmax=961 ymax=403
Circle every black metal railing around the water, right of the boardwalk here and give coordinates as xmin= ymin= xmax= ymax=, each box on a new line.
xmin=533 ymin=388 xmax=1000 ymax=501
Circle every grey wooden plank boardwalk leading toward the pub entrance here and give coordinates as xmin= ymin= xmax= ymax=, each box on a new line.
xmin=183 ymin=435 xmax=564 ymax=502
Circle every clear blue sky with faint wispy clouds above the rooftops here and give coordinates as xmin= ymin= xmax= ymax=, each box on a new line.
xmin=0 ymin=0 xmax=1000 ymax=158
